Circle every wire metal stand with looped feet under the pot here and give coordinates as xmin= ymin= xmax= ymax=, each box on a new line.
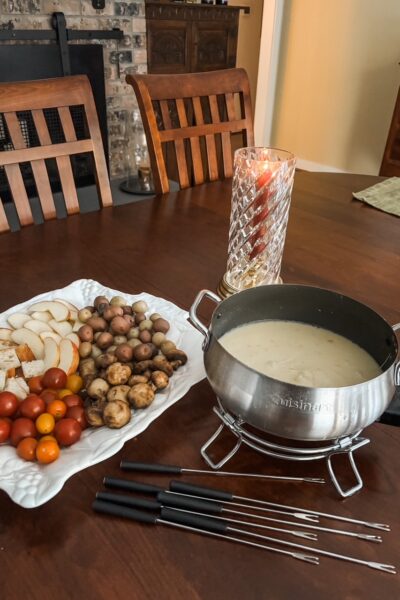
xmin=200 ymin=399 xmax=370 ymax=498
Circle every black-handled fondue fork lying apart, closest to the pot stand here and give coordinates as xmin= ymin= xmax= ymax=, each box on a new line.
xmin=120 ymin=460 xmax=325 ymax=483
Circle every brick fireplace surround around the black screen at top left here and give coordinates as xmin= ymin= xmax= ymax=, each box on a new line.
xmin=0 ymin=0 xmax=147 ymax=178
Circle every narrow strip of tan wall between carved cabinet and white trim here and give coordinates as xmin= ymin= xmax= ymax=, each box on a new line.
xmin=229 ymin=0 xmax=264 ymax=107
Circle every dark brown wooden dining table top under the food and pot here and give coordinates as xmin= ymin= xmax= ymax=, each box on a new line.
xmin=0 ymin=172 xmax=400 ymax=600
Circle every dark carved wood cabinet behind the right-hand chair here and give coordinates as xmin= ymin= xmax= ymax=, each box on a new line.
xmin=146 ymin=1 xmax=242 ymax=73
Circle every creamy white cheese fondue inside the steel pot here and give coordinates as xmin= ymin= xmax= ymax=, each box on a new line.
xmin=219 ymin=321 xmax=381 ymax=387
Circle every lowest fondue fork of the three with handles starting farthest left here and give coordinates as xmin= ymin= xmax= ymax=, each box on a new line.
xmin=92 ymin=499 xmax=319 ymax=565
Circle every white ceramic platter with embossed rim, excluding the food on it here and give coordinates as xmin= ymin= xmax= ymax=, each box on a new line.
xmin=0 ymin=279 xmax=205 ymax=508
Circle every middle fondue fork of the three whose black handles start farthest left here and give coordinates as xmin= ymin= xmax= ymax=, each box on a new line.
xmin=96 ymin=492 xmax=318 ymax=542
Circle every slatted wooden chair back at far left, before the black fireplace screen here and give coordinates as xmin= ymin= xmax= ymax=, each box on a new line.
xmin=0 ymin=75 xmax=112 ymax=231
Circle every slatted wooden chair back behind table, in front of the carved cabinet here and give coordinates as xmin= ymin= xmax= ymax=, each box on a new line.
xmin=126 ymin=69 xmax=254 ymax=193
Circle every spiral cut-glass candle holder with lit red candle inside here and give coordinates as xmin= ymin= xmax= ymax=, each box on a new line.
xmin=218 ymin=147 xmax=296 ymax=297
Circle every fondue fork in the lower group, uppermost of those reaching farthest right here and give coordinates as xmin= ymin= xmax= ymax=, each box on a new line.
xmin=170 ymin=481 xmax=390 ymax=531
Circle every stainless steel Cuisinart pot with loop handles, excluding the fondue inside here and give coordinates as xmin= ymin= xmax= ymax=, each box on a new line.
xmin=190 ymin=284 xmax=400 ymax=441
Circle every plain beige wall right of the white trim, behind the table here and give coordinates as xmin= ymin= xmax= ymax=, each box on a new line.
xmin=266 ymin=0 xmax=400 ymax=174
